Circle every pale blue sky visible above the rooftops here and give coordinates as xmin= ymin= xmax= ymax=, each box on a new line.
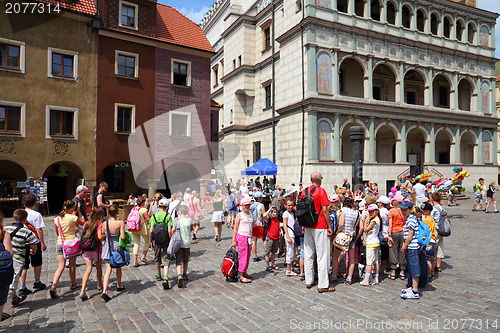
xmin=158 ymin=0 xmax=500 ymax=58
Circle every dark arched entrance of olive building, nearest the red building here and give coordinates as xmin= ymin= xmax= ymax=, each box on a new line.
xmin=43 ymin=161 xmax=83 ymax=213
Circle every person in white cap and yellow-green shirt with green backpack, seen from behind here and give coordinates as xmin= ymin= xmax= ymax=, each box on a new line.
xmin=149 ymin=199 xmax=174 ymax=290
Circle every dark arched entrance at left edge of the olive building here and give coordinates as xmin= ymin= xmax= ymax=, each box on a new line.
xmin=0 ymin=160 xmax=27 ymax=216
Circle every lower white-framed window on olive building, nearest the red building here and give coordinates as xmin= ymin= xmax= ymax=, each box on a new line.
xmin=45 ymin=105 xmax=78 ymax=139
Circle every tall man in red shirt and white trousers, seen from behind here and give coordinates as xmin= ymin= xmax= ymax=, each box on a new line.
xmin=300 ymin=172 xmax=335 ymax=293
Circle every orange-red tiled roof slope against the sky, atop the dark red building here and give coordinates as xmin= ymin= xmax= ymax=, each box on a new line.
xmin=156 ymin=3 xmax=213 ymax=52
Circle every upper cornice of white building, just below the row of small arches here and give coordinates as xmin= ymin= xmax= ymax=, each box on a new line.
xmin=276 ymin=16 xmax=497 ymax=62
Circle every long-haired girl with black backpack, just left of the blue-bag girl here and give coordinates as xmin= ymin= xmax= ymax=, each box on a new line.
xmin=80 ymin=207 xmax=105 ymax=301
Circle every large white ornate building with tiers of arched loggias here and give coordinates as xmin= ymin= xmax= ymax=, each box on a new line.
xmin=201 ymin=0 xmax=498 ymax=190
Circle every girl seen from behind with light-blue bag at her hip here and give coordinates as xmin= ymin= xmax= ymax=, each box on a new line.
xmin=98 ymin=205 xmax=127 ymax=302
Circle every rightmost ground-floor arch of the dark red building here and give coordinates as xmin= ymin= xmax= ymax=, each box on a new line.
xmin=157 ymin=162 xmax=201 ymax=197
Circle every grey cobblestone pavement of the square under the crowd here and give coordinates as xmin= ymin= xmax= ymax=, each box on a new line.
xmin=0 ymin=200 xmax=500 ymax=332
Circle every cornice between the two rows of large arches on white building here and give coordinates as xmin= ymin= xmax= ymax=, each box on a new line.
xmin=276 ymin=97 xmax=499 ymax=129
